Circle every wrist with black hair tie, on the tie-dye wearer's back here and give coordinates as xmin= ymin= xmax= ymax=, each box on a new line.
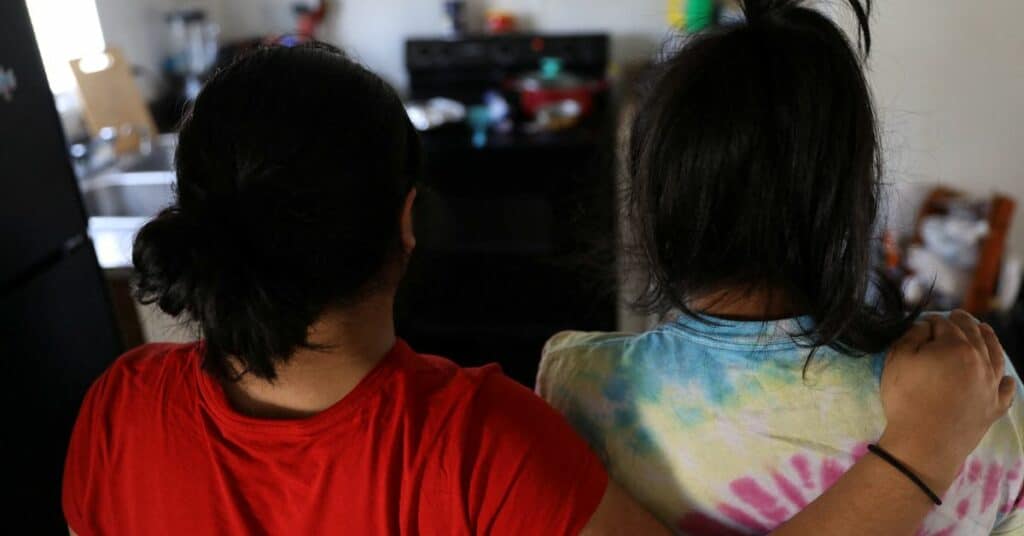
xmin=878 ymin=428 xmax=967 ymax=497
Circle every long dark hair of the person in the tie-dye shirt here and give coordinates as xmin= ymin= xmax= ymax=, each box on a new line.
xmin=628 ymin=0 xmax=916 ymax=354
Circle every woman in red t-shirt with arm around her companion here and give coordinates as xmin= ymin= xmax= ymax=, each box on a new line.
xmin=63 ymin=45 xmax=1009 ymax=536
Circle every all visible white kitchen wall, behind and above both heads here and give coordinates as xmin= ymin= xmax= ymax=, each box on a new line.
xmin=97 ymin=0 xmax=1024 ymax=253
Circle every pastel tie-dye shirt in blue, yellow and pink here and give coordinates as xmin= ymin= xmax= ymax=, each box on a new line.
xmin=538 ymin=318 xmax=1024 ymax=536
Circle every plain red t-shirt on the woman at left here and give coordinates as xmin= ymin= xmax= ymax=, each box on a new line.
xmin=63 ymin=341 xmax=607 ymax=536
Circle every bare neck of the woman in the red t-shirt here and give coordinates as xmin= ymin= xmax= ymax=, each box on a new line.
xmin=223 ymin=293 xmax=395 ymax=419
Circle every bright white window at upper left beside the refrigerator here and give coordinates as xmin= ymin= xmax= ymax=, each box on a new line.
xmin=27 ymin=0 xmax=105 ymax=95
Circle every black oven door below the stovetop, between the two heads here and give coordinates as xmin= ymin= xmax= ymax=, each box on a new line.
xmin=398 ymin=140 xmax=615 ymax=386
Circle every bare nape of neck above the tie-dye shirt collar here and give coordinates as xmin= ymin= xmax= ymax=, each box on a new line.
xmin=689 ymin=288 xmax=802 ymax=320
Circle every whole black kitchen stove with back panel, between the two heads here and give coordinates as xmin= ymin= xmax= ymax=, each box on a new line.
xmin=398 ymin=34 xmax=616 ymax=386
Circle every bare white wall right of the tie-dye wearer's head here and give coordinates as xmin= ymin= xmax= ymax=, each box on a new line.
xmin=870 ymin=0 xmax=1024 ymax=253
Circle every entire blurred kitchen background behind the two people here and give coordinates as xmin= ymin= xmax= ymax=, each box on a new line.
xmin=0 ymin=0 xmax=1024 ymax=521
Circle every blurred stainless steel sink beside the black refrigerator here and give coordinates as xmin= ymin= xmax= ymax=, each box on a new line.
xmin=80 ymin=136 xmax=176 ymax=269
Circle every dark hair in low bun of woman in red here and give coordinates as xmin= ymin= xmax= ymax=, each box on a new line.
xmin=132 ymin=43 xmax=420 ymax=379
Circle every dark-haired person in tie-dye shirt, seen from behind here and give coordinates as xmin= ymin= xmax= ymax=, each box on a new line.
xmin=539 ymin=0 xmax=1024 ymax=535
